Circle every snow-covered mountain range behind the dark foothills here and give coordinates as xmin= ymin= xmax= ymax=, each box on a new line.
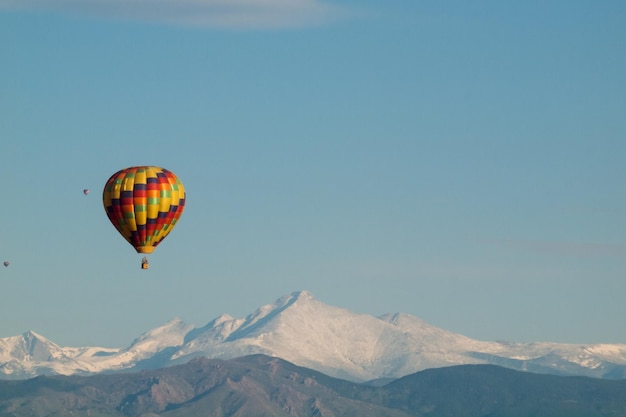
xmin=0 ymin=291 xmax=626 ymax=381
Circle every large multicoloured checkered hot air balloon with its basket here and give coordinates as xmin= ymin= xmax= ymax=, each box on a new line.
xmin=102 ymin=166 xmax=186 ymax=269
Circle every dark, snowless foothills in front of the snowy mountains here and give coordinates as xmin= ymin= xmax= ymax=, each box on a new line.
xmin=0 ymin=355 xmax=626 ymax=417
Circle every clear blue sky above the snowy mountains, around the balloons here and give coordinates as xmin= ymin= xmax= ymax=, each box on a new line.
xmin=0 ymin=0 xmax=626 ymax=347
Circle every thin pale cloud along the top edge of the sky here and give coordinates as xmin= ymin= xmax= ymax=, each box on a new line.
xmin=0 ymin=0 xmax=348 ymax=29
